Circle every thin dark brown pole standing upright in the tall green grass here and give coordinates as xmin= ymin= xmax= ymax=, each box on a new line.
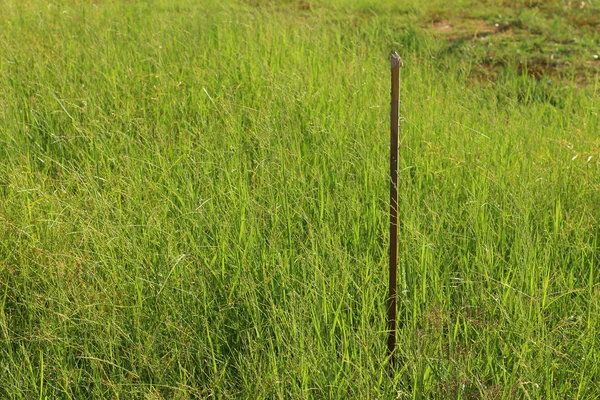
xmin=387 ymin=51 xmax=402 ymax=367
